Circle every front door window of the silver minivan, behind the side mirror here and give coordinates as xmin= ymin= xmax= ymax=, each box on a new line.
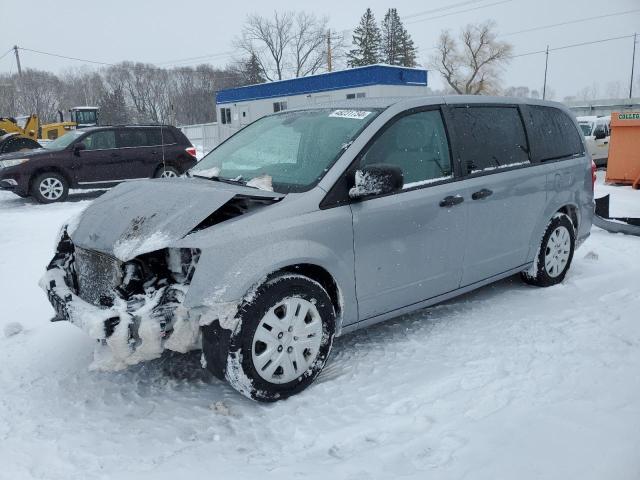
xmin=360 ymin=110 xmax=452 ymax=188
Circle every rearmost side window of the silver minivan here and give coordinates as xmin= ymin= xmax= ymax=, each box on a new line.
xmin=527 ymin=105 xmax=584 ymax=162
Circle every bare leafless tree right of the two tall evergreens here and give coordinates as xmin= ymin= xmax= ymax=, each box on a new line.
xmin=430 ymin=22 xmax=512 ymax=95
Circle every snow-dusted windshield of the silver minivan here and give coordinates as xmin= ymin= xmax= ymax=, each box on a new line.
xmin=190 ymin=109 xmax=379 ymax=193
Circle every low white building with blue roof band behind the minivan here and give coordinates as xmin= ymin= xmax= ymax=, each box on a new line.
xmin=216 ymin=65 xmax=428 ymax=141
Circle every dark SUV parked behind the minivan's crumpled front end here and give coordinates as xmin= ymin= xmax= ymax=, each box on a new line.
xmin=0 ymin=125 xmax=197 ymax=203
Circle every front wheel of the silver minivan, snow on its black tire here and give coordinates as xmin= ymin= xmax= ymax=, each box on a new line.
xmin=202 ymin=274 xmax=336 ymax=402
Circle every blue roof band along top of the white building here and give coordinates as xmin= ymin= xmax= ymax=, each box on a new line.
xmin=216 ymin=65 xmax=427 ymax=104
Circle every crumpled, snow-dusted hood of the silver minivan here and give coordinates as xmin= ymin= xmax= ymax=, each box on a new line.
xmin=67 ymin=178 xmax=284 ymax=261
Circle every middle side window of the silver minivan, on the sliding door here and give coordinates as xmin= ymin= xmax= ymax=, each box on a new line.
xmin=452 ymin=106 xmax=529 ymax=173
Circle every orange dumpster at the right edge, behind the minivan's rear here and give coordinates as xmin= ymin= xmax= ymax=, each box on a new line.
xmin=606 ymin=112 xmax=640 ymax=188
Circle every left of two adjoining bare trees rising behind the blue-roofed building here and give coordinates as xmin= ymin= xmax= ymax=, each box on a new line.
xmin=236 ymin=12 xmax=294 ymax=80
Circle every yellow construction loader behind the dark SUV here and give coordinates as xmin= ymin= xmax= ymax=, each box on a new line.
xmin=0 ymin=107 xmax=98 ymax=154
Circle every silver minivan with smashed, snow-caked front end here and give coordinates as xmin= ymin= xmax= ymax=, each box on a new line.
xmin=41 ymin=96 xmax=594 ymax=401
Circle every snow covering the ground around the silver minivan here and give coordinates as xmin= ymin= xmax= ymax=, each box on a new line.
xmin=0 ymin=175 xmax=640 ymax=480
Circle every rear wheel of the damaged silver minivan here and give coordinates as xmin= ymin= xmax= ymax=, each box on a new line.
xmin=520 ymin=213 xmax=576 ymax=287
